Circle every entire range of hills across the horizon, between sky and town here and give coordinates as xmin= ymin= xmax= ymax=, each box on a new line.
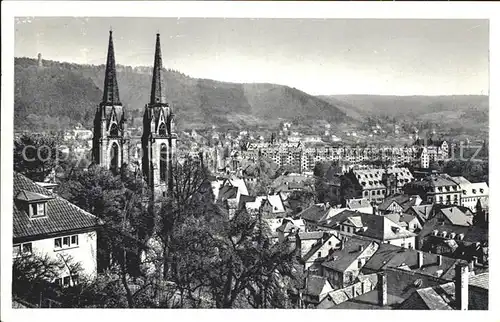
xmin=14 ymin=58 xmax=489 ymax=135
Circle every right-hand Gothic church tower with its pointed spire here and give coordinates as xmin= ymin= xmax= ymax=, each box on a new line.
xmin=142 ymin=34 xmax=177 ymax=198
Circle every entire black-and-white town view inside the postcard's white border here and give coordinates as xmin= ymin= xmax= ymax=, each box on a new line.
xmin=1 ymin=1 xmax=500 ymax=321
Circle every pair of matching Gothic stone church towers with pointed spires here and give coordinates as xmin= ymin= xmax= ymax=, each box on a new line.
xmin=92 ymin=31 xmax=177 ymax=198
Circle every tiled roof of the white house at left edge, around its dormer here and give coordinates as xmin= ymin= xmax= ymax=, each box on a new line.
xmin=12 ymin=172 xmax=98 ymax=239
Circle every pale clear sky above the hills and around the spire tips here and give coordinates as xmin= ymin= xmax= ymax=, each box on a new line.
xmin=15 ymin=17 xmax=489 ymax=95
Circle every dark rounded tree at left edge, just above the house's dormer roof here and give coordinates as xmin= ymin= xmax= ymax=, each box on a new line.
xmin=14 ymin=134 xmax=64 ymax=182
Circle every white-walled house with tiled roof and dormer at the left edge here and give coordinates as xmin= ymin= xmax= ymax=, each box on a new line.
xmin=12 ymin=173 xmax=99 ymax=286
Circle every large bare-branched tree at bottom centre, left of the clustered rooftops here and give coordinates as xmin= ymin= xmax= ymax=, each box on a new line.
xmin=178 ymin=211 xmax=297 ymax=308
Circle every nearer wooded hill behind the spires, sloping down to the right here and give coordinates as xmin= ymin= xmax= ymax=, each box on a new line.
xmin=15 ymin=58 xmax=357 ymax=130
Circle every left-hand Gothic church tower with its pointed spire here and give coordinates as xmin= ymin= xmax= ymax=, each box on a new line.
xmin=92 ymin=31 xmax=128 ymax=173
